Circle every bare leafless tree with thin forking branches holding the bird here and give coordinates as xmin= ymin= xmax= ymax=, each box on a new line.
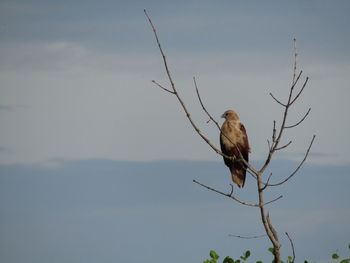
xmin=144 ymin=10 xmax=315 ymax=263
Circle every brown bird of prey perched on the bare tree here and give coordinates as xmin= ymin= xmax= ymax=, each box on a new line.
xmin=220 ymin=110 xmax=250 ymax=187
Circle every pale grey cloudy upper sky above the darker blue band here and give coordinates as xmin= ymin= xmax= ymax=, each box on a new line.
xmin=0 ymin=1 xmax=350 ymax=163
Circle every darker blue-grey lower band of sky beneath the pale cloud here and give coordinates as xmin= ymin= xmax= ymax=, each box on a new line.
xmin=0 ymin=160 xmax=350 ymax=263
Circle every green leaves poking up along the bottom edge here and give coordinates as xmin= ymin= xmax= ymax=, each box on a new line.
xmin=203 ymin=244 xmax=350 ymax=263
